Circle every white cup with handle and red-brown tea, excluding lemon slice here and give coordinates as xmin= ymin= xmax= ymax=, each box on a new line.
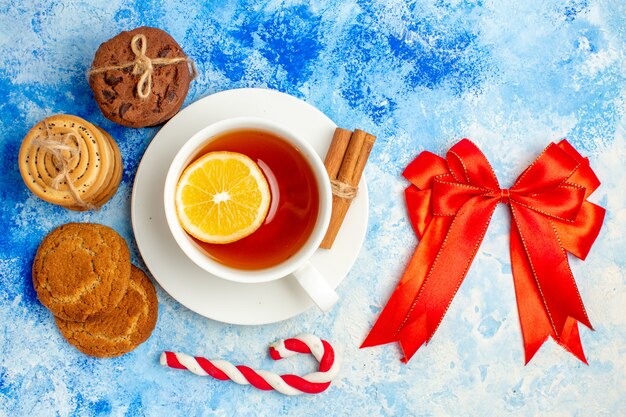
xmin=164 ymin=117 xmax=338 ymax=311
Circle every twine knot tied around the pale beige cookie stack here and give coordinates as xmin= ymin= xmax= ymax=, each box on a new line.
xmin=31 ymin=123 xmax=93 ymax=209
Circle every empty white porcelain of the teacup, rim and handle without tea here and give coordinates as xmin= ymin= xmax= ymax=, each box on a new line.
xmin=164 ymin=117 xmax=338 ymax=311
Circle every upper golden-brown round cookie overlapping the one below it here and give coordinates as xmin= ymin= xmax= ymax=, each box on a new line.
xmin=33 ymin=223 xmax=130 ymax=321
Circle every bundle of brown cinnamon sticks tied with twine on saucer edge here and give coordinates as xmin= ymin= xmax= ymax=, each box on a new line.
xmin=320 ymin=128 xmax=376 ymax=249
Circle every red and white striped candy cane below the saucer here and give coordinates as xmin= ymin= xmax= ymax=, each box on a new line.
xmin=161 ymin=334 xmax=339 ymax=395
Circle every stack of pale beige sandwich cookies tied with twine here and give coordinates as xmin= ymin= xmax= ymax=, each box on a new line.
xmin=18 ymin=114 xmax=123 ymax=211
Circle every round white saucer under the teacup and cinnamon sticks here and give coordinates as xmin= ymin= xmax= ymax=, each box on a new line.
xmin=131 ymin=88 xmax=368 ymax=324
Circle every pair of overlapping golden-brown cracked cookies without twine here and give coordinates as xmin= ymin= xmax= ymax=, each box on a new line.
xmin=33 ymin=223 xmax=158 ymax=358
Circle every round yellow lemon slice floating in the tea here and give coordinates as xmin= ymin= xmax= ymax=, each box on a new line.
xmin=175 ymin=152 xmax=271 ymax=243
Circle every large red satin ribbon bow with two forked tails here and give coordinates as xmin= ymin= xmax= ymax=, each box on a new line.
xmin=361 ymin=139 xmax=605 ymax=363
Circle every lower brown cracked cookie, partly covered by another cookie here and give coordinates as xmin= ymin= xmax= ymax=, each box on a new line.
xmin=55 ymin=265 xmax=158 ymax=358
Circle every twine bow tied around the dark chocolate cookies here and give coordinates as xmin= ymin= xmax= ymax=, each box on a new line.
xmin=89 ymin=34 xmax=197 ymax=99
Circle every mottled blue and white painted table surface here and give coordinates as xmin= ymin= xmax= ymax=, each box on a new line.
xmin=0 ymin=0 xmax=626 ymax=417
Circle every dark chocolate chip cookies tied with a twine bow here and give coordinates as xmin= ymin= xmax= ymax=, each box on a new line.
xmin=89 ymin=26 xmax=195 ymax=127
